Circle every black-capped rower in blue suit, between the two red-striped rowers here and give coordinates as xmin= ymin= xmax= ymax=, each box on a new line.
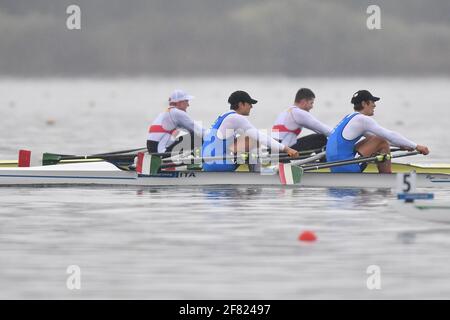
xmin=202 ymin=91 xmax=298 ymax=171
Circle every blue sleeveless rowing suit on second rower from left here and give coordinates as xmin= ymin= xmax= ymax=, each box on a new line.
xmin=202 ymin=111 xmax=236 ymax=171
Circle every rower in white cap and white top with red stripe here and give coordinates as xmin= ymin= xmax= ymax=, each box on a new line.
xmin=147 ymin=90 xmax=203 ymax=153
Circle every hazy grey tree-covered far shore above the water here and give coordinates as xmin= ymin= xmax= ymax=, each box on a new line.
xmin=0 ymin=0 xmax=450 ymax=76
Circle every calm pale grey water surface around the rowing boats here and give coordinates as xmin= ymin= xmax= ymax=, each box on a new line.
xmin=0 ymin=78 xmax=450 ymax=299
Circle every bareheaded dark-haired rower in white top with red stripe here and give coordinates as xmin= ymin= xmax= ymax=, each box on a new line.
xmin=272 ymin=88 xmax=331 ymax=151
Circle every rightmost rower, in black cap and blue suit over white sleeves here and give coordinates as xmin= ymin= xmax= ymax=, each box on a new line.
xmin=326 ymin=90 xmax=429 ymax=173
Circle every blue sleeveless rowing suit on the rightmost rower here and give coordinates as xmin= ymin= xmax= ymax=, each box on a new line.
xmin=326 ymin=112 xmax=362 ymax=172
